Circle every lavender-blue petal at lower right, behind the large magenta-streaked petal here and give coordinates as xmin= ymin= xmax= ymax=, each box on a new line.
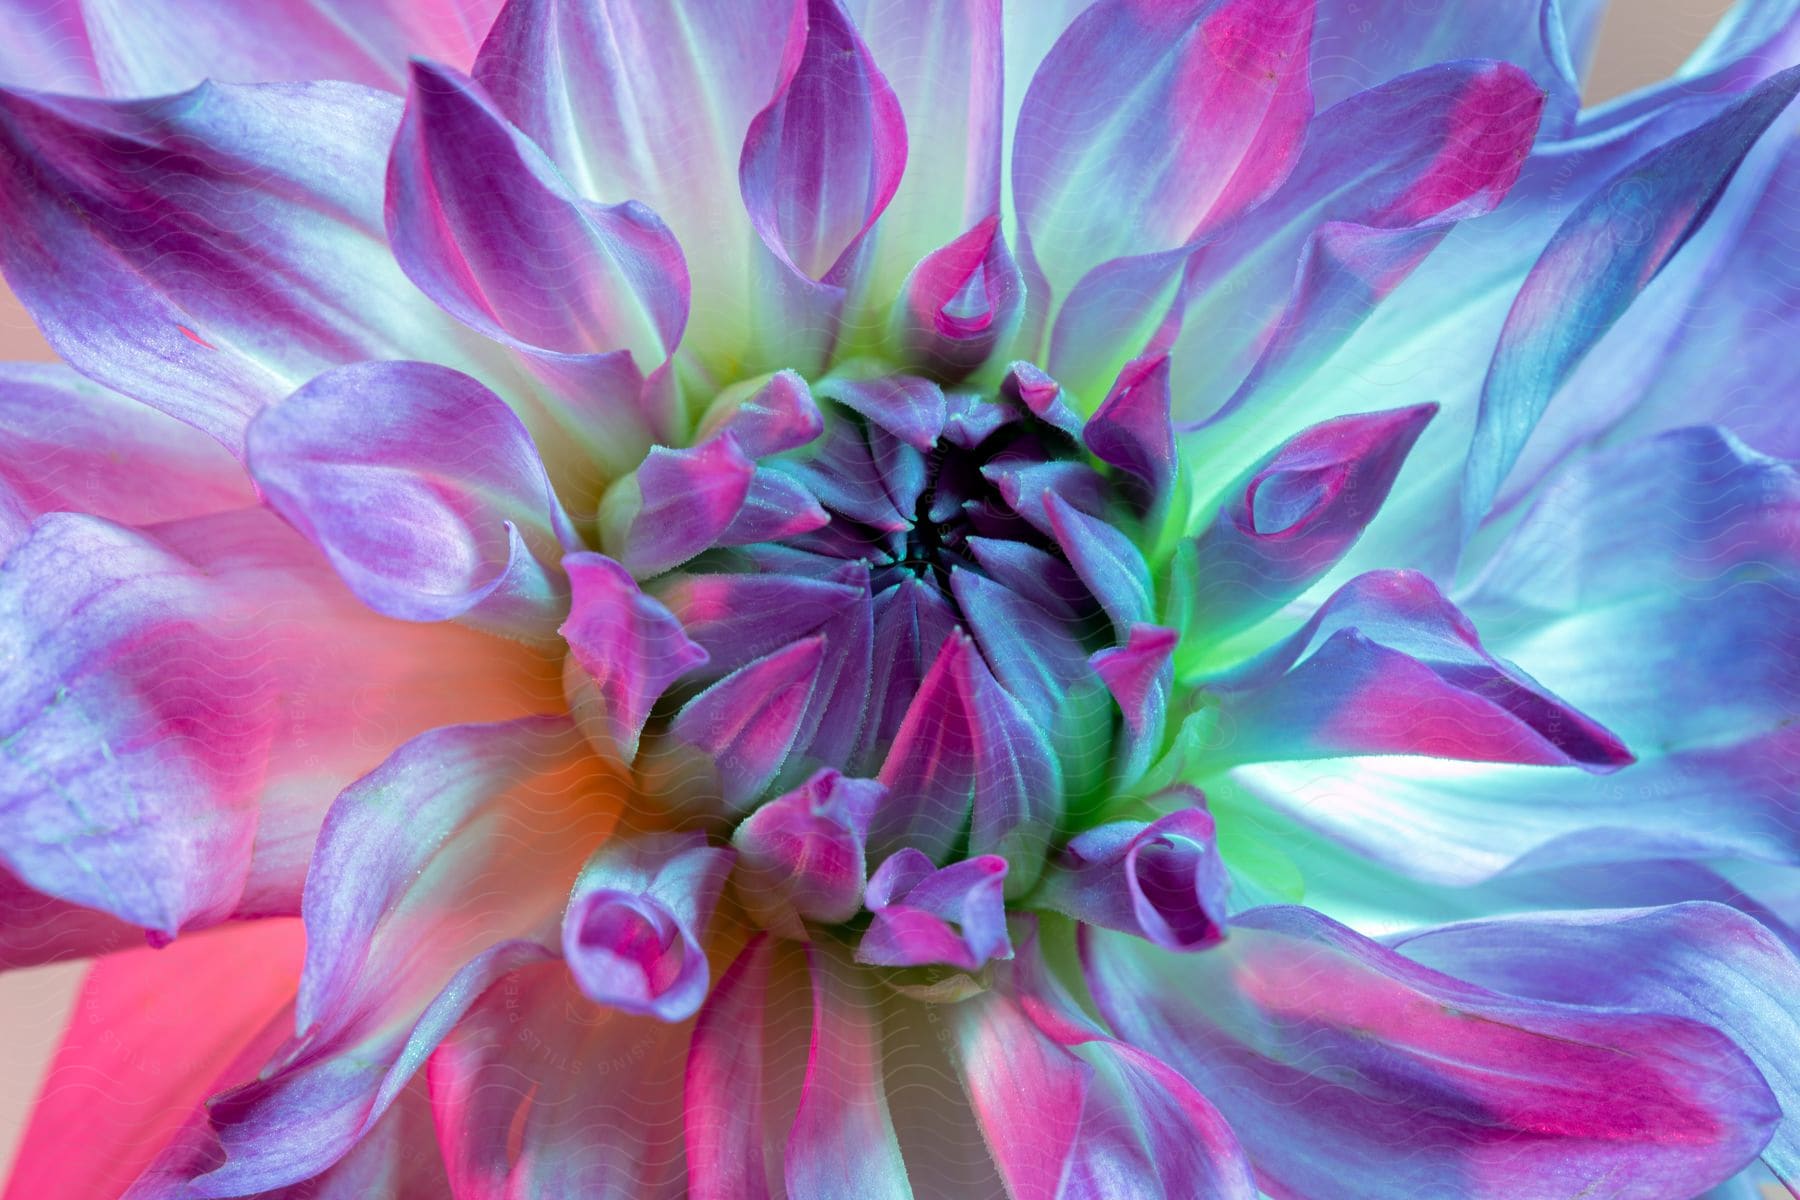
xmin=1390 ymin=903 xmax=1800 ymax=1182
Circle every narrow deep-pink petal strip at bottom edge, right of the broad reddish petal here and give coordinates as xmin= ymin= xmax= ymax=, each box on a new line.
xmin=684 ymin=934 xmax=772 ymax=1200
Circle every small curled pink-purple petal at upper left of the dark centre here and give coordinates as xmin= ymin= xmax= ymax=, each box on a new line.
xmin=599 ymin=434 xmax=756 ymax=578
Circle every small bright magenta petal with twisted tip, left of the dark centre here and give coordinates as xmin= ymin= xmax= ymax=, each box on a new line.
xmin=558 ymin=552 xmax=707 ymax=763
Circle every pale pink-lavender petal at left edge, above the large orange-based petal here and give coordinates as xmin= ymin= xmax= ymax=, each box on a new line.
xmin=0 ymin=363 xmax=256 ymax=554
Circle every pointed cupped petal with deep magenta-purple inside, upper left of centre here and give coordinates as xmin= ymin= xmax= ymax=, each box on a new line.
xmin=387 ymin=63 xmax=688 ymax=449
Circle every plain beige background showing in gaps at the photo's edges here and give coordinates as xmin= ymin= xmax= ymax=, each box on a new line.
xmin=0 ymin=0 xmax=1730 ymax=1178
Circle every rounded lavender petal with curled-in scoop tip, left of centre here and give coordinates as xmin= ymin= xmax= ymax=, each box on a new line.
xmin=247 ymin=362 xmax=580 ymax=640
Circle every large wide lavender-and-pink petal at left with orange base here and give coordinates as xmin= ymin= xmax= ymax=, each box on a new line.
xmin=0 ymin=511 xmax=554 ymax=936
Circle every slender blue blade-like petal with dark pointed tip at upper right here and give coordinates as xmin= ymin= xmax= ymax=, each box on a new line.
xmin=1462 ymin=68 xmax=1800 ymax=536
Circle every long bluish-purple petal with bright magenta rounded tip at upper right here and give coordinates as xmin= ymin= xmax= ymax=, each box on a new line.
xmin=1173 ymin=59 xmax=1544 ymax=437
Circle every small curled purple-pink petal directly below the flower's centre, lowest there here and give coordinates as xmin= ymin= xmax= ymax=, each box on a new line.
xmin=857 ymin=847 xmax=1012 ymax=972
